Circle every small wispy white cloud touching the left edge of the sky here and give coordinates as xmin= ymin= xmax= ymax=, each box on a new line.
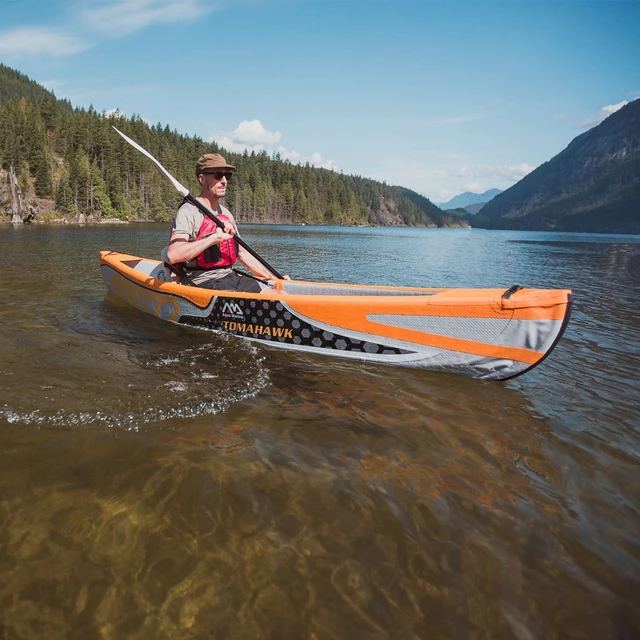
xmin=0 ymin=27 xmax=89 ymax=57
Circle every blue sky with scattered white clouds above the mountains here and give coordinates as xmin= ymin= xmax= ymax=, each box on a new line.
xmin=0 ymin=0 xmax=640 ymax=202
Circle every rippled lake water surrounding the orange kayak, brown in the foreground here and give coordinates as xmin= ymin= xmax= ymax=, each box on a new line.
xmin=0 ymin=225 xmax=640 ymax=640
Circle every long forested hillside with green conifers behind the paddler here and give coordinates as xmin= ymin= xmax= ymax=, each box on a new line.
xmin=0 ymin=64 xmax=444 ymax=227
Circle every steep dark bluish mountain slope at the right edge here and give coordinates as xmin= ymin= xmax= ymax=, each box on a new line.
xmin=474 ymin=100 xmax=640 ymax=233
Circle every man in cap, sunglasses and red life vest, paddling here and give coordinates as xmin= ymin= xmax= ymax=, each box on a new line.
xmin=167 ymin=153 xmax=277 ymax=293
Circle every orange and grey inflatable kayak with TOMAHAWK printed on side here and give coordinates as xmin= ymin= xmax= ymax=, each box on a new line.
xmin=100 ymin=251 xmax=571 ymax=380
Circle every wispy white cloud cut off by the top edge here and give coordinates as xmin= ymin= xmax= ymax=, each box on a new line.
xmin=78 ymin=0 xmax=215 ymax=37
